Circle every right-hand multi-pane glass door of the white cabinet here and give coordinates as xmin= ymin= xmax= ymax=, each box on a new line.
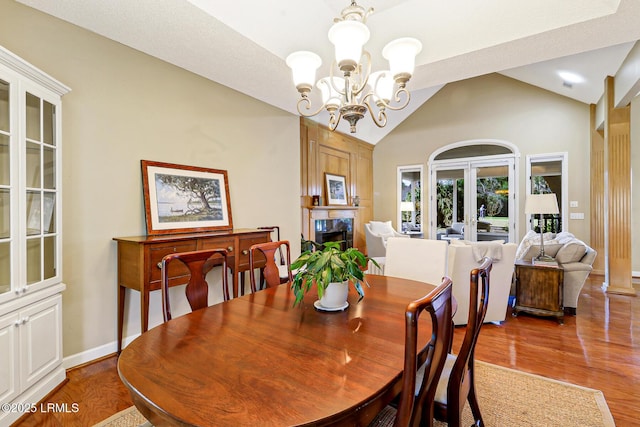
xmin=24 ymin=92 xmax=58 ymax=286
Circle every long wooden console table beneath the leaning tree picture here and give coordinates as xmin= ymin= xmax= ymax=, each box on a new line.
xmin=113 ymin=229 xmax=272 ymax=354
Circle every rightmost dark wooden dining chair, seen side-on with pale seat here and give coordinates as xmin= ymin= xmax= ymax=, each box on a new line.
xmin=434 ymin=258 xmax=493 ymax=427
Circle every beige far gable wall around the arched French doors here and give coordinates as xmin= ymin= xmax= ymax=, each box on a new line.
xmin=373 ymin=74 xmax=589 ymax=242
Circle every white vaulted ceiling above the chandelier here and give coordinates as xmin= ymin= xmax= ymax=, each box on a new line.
xmin=17 ymin=0 xmax=640 ymax=143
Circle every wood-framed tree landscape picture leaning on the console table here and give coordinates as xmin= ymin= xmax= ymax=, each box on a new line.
xmin=141 ymin=160 xmax=233 ymax=234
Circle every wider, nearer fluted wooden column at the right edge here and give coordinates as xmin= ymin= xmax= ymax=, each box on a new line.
xmin=604 ymin=76 xmax=636 ymax=295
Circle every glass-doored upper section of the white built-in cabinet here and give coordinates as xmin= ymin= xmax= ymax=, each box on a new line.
xmin=0 ymin=46 xmax=70 ymax=308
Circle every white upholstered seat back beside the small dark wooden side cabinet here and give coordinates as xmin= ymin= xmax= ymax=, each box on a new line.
xmin=447 ymin=240 xmax=517 ymax=325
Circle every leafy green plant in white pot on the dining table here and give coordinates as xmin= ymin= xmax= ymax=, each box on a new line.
xmin=291 ymin=242 xmax=379 ymax=311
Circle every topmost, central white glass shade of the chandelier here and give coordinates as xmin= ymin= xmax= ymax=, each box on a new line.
xmin=329 ymin=21 xmax=370 ymax=71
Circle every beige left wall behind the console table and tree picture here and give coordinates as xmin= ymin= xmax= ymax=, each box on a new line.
xmin=0 ymin=0 xmax=301 ymax=356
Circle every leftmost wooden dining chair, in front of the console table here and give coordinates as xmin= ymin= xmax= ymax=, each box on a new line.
xmin=160 ymin=249 xmax=229 ymax=322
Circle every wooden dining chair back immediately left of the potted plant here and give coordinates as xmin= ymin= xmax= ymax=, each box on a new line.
xmin=249 ymin=240 xmax=293 ymax=292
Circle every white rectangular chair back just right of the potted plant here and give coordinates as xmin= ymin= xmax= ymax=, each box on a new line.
xmin=384 ymin=237 xmax=449 ymax=284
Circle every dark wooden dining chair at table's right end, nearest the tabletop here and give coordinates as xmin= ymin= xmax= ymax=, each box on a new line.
xmin=369 ymin=277 xmax=453 ymax=427
